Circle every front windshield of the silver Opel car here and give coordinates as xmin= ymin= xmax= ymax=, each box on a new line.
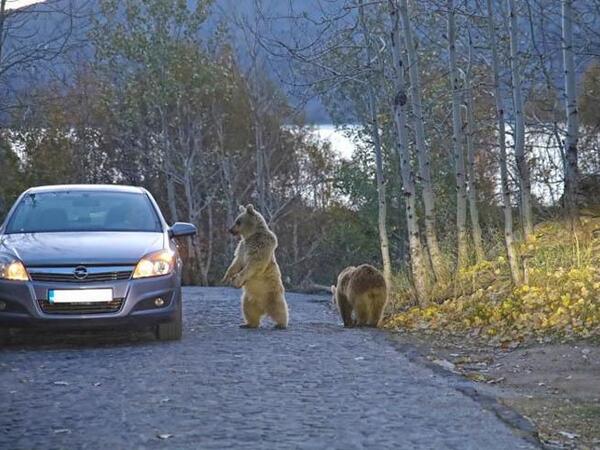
xmin=6 ymin=191 xmax=162 ymax=233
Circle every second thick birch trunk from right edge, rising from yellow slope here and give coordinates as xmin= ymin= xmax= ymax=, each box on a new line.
xmin=507 ymin=0 xmax=533 ymax=240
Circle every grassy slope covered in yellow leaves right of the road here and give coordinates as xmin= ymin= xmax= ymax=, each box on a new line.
xmin=386 ymin=218 xmax=600 ymax=344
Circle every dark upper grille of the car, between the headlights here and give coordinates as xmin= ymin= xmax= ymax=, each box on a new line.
xmin=29 ymin=266 xmax=134 ymax=283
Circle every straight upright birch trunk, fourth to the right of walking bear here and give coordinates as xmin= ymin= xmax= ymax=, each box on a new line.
xmin=447 ymin=0 xmax=468 ymax=270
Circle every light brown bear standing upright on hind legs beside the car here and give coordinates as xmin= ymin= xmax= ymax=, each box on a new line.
xmin=223 ymin=205 xmax=288 ymax=328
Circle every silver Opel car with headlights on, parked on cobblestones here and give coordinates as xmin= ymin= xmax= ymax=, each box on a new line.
xmin=0 ymin=185 xmax=196 ymax=340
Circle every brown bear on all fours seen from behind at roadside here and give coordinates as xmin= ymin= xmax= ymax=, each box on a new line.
xmin=331 ymin=264 xmax=387 ymax=327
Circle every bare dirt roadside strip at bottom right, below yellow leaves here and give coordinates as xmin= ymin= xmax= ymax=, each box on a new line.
xmin=394 ymin=332 xmax=600 ymax=449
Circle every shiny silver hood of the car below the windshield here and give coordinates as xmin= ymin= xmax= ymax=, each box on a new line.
xmin=0 ymin=232 xmax=165 ymax=267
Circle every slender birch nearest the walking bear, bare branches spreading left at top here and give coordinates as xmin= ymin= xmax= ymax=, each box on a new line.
xmin=255 ymin=0 xmax=392 ymax=285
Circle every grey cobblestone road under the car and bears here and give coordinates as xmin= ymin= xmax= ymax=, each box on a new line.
xmin=0 ymin=288 xmax=531 ymax=450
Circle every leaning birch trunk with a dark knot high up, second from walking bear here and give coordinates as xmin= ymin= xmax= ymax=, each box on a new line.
xmin=388 ymin=0 xmax=428 ymax=304
